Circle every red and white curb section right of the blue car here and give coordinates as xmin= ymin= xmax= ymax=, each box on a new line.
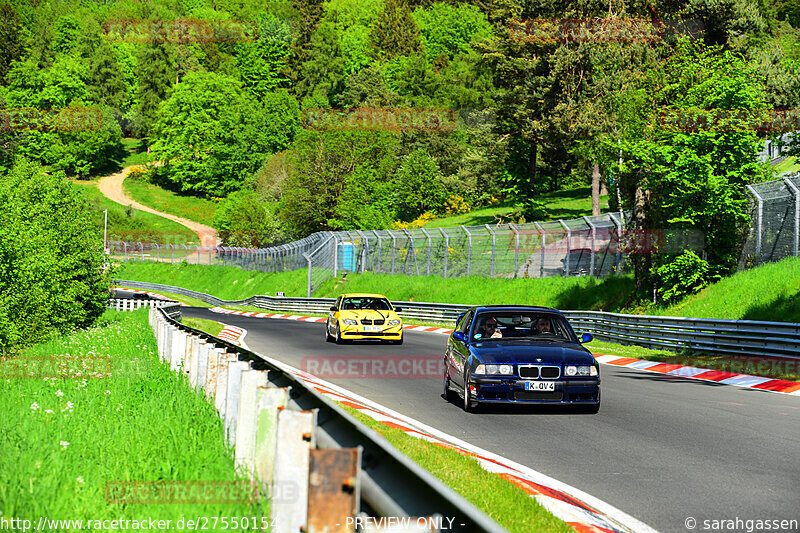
xmin=595 ymin=354 xmax=800 ymax=396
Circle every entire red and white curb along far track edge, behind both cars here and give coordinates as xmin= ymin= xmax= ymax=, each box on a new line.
xmin=210 ymin=307 xmax=800 ymax=396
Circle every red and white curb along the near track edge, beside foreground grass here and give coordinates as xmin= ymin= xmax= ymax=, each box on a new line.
xmin=221 ymin=324 xmax=655 ymax=533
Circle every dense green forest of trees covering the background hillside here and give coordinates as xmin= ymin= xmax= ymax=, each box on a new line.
xmin=0 ymin=0 xmax=800 ymax=302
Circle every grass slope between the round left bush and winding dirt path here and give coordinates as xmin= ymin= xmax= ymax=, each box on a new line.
xmin=72 ymin=180 xmax=197 ymax=244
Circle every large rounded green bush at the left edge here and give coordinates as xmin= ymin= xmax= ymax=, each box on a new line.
xmin=0 ymin=160 xmax=109 ymax=353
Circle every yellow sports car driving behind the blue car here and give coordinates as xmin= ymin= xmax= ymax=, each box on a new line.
xmin=325 ymin=294 xmax=403 ymax=344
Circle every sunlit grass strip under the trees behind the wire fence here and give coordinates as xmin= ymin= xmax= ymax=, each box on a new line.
xmin=425 ymin=187 xmax=608 ymax=228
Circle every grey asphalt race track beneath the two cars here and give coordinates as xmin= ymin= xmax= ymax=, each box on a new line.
xmin=182 ymin=307 xmax=800 ymax=532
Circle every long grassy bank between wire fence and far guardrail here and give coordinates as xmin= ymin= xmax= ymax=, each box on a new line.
xmin=115 ymin=258 xmax=800 ymax=322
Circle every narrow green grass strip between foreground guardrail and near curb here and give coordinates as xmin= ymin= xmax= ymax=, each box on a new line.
xmin=344 ymin=407 xmax=575 ymax=533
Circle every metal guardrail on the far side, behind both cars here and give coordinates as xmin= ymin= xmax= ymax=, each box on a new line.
xmin=117 ymin=280 xmax=800 ymax=359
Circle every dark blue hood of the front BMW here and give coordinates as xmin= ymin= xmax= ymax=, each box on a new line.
xmin=471 ymin=340 xmax=595 ymax=365
